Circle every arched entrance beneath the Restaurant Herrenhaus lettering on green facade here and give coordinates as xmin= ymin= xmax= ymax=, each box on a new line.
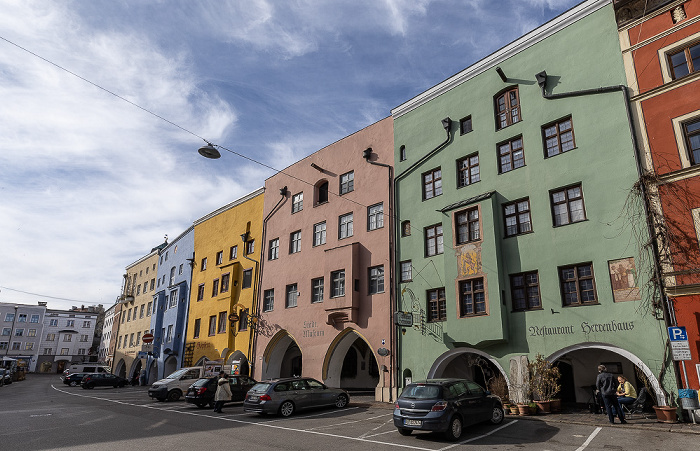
xmin=547 ymin=342 xmax=667 ymax=406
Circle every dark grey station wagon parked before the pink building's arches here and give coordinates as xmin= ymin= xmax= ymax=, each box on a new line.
xmin=243 ymin=377 xmax=350 ymax=417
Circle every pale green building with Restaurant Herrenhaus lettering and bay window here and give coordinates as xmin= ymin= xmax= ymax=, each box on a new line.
xmin=392 ymin=0 xmax=674 ymax=405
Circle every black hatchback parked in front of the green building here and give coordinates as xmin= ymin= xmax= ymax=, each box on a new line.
xmin=394 ymin=379 xmax=504 ymax=441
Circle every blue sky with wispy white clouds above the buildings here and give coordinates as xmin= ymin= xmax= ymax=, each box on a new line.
xmin=0 ymin=0 xmax=579 ymax=309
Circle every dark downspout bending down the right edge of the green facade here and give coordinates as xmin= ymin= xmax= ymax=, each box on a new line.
xmin=535 ymin=71 xmax=682 ymax=394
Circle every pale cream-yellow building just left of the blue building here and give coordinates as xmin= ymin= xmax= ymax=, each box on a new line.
xmin=112 ymin=242 xmax=167 ymax=380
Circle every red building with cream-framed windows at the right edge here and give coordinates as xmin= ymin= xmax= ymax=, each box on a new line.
xmin=614 ymin=0 xmax=700 ymax=389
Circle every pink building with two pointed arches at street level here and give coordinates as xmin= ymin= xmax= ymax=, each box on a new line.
xmin=254 ymin=117 xmax=395 ymax=401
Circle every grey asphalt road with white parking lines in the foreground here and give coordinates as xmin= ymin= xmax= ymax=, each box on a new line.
xmin=0 ymin=374 xmax=698 ymax=451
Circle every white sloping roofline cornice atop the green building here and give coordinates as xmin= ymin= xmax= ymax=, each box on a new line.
xmin=391 ymin=0 xmax=612 ymax=119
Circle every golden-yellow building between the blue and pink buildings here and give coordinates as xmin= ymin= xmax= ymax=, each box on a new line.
xmin=183 ymin=188 xmax=264 ymax=374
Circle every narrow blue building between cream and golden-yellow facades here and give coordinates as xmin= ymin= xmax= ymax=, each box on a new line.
xmin=146 ymin=226 xmax=194 ymax=384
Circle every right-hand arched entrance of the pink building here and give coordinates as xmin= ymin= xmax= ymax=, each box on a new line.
xmin=323 ymin=329 xmax=379 ymax=390
